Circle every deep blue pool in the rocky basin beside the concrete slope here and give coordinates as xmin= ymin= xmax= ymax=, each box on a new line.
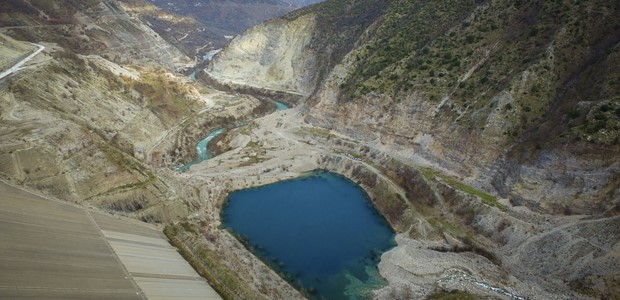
xmin=222 ymin=172 xmax=395 ymax=299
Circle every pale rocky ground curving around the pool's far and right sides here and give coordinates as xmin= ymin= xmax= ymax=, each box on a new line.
xmin=167 ymin=104 xmax=620 ymax=299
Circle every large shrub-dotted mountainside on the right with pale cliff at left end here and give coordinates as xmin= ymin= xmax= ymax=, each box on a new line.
xmin=209 ymin=0 xmax=620 ymax=214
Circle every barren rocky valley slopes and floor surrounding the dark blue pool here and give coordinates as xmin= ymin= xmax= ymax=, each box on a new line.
xmin=0 ymin=0 xmax=620 ymax=299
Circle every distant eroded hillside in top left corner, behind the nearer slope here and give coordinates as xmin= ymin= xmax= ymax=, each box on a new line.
xmin=0 ymin=0 xmax=189 ymax=67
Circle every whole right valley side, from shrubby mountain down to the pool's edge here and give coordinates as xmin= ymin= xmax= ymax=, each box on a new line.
xmin=205 ymin=0 xmax=620 ymax=298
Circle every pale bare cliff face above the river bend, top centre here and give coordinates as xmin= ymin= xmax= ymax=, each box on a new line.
xmin=207 ymin=14 xmax=317 ymax=96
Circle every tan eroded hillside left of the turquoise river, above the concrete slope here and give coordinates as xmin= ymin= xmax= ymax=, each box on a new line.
xmin=0 ymin=1 xmax=272 ymax=222
